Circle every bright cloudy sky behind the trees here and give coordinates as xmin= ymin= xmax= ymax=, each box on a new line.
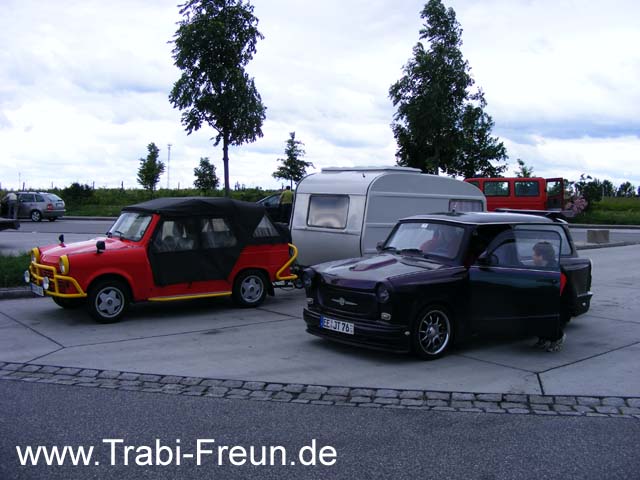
xmin=0 ymin=0 xmax=640 ymax=188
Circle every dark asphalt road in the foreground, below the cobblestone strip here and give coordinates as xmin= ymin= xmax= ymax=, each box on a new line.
xmin=0 ymin=381 xmax=640 ymax=480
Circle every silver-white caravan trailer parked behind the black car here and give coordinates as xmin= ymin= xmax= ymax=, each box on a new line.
xmin=291 ymin=167 xmax=487 ymax=266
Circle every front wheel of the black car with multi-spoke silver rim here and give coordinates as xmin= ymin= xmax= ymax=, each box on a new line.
xmin=411 ymin=305 xmax=454 ymax=360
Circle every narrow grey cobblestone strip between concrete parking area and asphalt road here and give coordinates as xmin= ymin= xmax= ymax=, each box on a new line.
xmin=0 ymin=362 xmax=640 ymax=420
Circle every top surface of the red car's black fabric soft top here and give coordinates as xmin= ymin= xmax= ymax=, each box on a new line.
xmin=122 ymin=197 xmax=265 ymax=221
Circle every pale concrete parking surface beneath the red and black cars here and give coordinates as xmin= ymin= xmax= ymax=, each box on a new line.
xmin=0 ymin=246 xmax=640 ymax=413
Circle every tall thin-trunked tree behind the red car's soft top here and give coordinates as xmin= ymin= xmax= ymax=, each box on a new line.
xmin=169 ymin=0 xmax=266 ymax=196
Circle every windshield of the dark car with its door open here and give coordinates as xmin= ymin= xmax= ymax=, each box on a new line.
xmin=384 ymin=222 xmax=464 ymax=259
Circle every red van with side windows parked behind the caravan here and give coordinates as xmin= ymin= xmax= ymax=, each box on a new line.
xmin=465 ymin=177 xmax=566 ymax=214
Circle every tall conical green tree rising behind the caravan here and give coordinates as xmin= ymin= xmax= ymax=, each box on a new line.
xmin=389 ymin=0 xmax=508 ymax=176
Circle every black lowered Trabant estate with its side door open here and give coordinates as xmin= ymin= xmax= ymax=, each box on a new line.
xmin=303 ymin=212 xmax=592 ymax=359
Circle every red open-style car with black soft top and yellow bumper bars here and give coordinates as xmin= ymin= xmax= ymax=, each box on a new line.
xmin=25 ymin=197 xmax=297 ymax=323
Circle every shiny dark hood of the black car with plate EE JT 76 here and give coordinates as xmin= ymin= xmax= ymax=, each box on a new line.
xmin=313 ymin=253 xmax=448 ymax=285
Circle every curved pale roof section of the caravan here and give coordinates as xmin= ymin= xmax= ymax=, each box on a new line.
xmin=296 ymin=167 xmax=484 ymax=198
